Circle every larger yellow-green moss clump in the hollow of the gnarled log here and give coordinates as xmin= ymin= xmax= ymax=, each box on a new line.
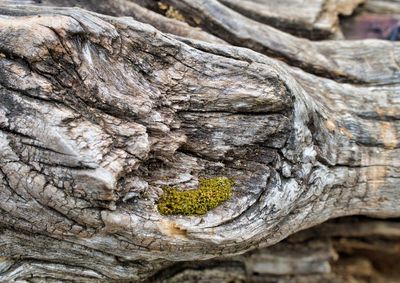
xmin=158 ymin=177 xmax=234 ymax=215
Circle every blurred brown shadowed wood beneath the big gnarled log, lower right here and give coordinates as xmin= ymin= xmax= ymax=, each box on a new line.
xmin=148 ymin=218 xmax=400 ymax=283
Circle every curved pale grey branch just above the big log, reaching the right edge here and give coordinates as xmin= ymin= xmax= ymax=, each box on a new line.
xmin=161 ymin=0 xmax=400 ymax=84
